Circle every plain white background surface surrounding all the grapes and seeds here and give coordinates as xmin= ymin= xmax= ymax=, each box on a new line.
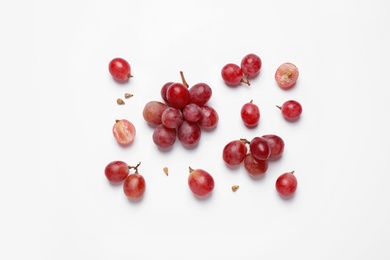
xmin=0 ymin=0 xmax=390 ymax=260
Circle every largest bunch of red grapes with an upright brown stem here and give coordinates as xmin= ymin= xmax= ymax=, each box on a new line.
xmin=143 ymin=71 xmax=219 ymax=150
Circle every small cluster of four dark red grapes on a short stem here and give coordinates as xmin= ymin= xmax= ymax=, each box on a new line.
xmin=222 ymin=134 xmax=284 ymax=177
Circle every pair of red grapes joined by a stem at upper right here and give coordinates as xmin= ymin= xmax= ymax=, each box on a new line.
xmin=221 ymin=53 xmax=262 ymax=86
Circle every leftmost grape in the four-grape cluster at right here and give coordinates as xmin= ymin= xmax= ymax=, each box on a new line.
xmin=222 ymin=140 xmax=248 ymax=167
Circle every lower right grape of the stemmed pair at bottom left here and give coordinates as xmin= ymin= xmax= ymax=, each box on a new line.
xmin=123 ymin=173 xmax=146 ymax=201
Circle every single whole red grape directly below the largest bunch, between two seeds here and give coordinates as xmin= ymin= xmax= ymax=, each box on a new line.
xmin=188 ymin=167 xmax=214 ymax=198
